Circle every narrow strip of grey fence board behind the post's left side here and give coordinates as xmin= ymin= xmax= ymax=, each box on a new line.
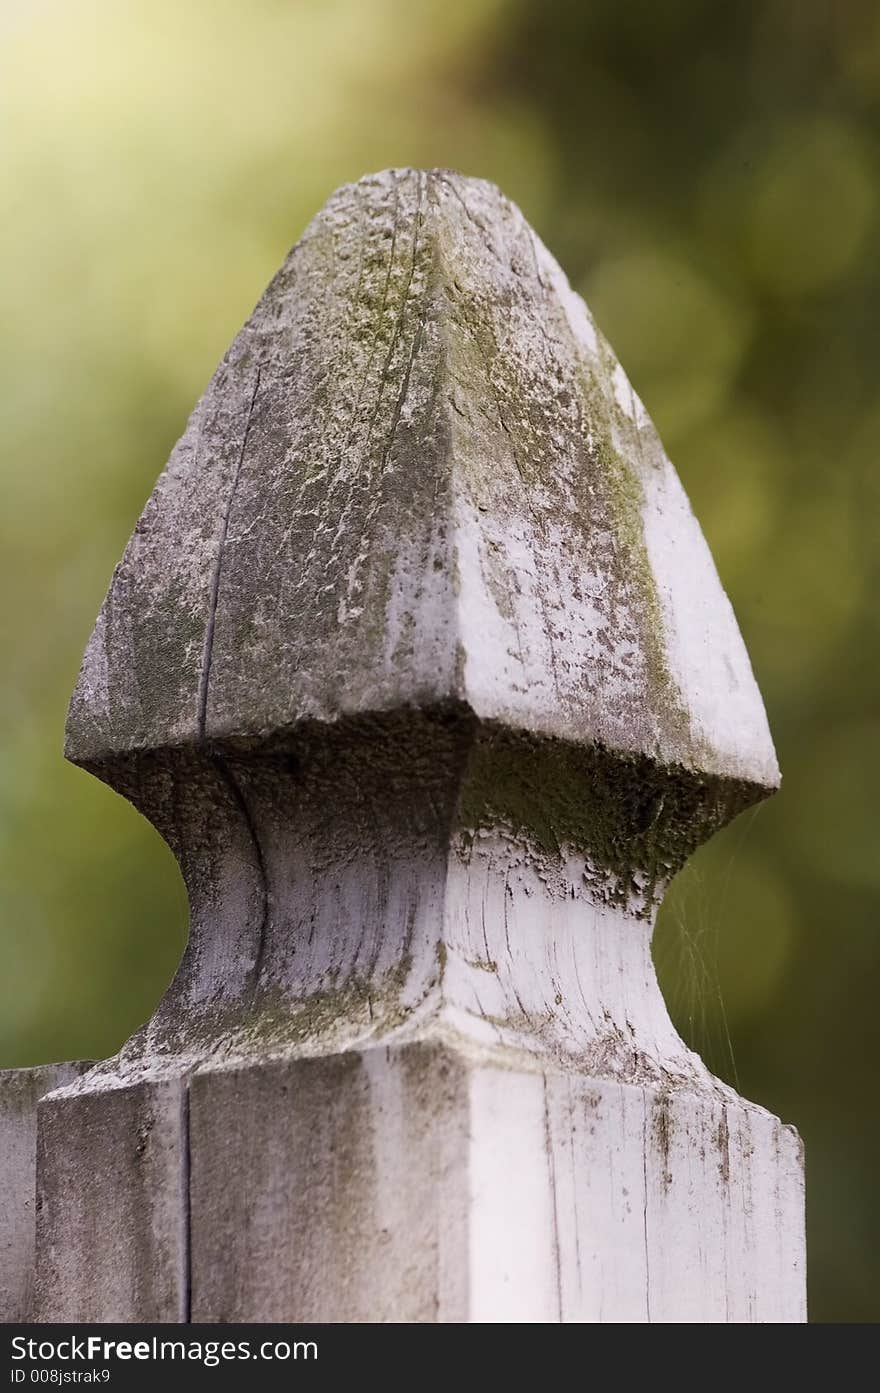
xmin=0 ymin=1063 xmax=89 ymax=1321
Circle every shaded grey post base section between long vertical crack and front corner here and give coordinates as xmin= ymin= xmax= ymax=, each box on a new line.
xmin=191 ymin=1045 xmax=468 ymax=1322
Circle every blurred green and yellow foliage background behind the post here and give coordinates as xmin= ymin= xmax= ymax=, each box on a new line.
xmin=0 ymin=0 xmax=880 ymax=1321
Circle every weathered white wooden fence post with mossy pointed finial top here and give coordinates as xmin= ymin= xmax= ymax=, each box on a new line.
xmin=36 ymin=170 xmax=805 ymax=1322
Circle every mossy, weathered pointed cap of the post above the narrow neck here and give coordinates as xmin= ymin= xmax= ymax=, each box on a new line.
xmin=68 ymin=170 xmax=776 ymax=784
